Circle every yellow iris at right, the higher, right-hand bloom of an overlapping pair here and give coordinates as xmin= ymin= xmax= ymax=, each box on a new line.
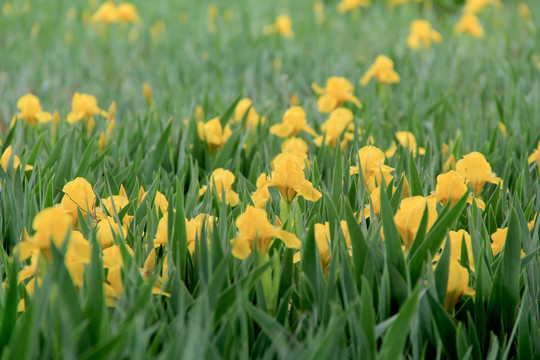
xmin=456 ymin=151 xmax=502 ymax=195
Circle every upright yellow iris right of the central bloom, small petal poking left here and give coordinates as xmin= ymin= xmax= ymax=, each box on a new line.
xmin=350 ymin=145 xmax=394 ymax=193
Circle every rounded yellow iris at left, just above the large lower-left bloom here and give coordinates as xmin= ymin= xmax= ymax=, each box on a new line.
xmin=60 ymin=177 xmax=96 ymax=227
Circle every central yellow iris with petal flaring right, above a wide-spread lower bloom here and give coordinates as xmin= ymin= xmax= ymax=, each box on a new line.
xmin=266 ymin=153 xmax=322 ymax=202
